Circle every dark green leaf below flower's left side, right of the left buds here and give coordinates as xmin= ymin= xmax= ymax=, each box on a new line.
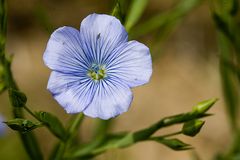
xmin=35 ymin=112 xmax=66 ymax=141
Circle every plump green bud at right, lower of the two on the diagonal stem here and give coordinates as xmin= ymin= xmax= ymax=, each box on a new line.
xmin=182 ymin=120 xmax=205 ymax=137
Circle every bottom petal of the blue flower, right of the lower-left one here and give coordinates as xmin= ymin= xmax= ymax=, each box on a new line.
xmin=83 ymin=79 xmax=133 ymax=119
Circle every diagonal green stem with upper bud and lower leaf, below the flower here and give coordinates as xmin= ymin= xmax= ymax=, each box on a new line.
xmin=66 ymin=99 xmax=217 ymax=158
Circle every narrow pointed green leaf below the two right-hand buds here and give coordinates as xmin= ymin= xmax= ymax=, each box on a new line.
xmin=151 ymin=137 xmax=192 ymax=151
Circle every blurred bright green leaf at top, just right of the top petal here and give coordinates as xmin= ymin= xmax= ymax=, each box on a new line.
xmin=125 ymin=0 xmax=148 ymax=31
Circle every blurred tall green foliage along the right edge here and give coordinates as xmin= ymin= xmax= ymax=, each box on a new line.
xmin=212 ymin=0 xmax=240 ymax=129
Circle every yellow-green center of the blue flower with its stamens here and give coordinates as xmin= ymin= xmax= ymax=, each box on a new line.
xmin=87 ymin=64 xmax=107 ymax=81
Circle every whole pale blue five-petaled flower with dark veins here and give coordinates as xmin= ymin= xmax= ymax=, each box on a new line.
xmin=43 ymin=14 xmax=152 ymax=119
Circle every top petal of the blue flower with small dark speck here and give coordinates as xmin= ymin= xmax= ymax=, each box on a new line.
xmin=80 ymin=13 xmax=128 ymax=64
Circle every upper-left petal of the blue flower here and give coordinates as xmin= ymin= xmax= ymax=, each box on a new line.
xmin=43 ymin=27 xmax=90 ymax=73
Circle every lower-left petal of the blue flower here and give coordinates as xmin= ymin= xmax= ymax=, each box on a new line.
xmin=47 ymin=71 xmax=96 ymax=113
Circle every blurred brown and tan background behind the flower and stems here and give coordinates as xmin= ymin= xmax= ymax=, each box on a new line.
xmin=0 ymin=0 xmax=236 ymax=160
